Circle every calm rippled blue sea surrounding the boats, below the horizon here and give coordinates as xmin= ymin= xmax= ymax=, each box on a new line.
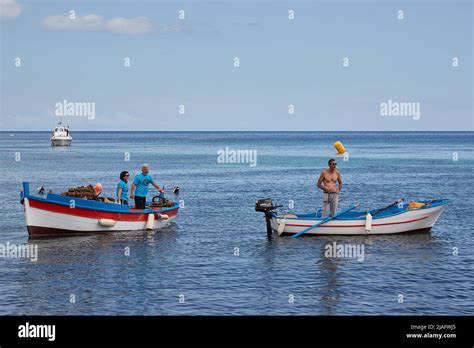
xmin=0 ymin=132 xmax=474 ymax=315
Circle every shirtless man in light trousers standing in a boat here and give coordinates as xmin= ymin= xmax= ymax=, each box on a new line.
xmin=316 ymin=159 xmax=342 ymax=218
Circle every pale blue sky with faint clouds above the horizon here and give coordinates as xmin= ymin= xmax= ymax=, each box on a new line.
xmin=0 ymin=0 xmax=474 ymax=131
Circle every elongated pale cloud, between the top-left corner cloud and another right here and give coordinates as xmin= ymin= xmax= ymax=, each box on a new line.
xmin=43 ymin=14 xmax=103 ymax=31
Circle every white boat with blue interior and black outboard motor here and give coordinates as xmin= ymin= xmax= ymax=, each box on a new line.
xmin=255 ymin=198 xmax=449 ymax=237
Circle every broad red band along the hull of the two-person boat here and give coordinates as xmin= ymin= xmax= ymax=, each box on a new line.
xmin=29 ymin=199 xmax=178 ymax=221
